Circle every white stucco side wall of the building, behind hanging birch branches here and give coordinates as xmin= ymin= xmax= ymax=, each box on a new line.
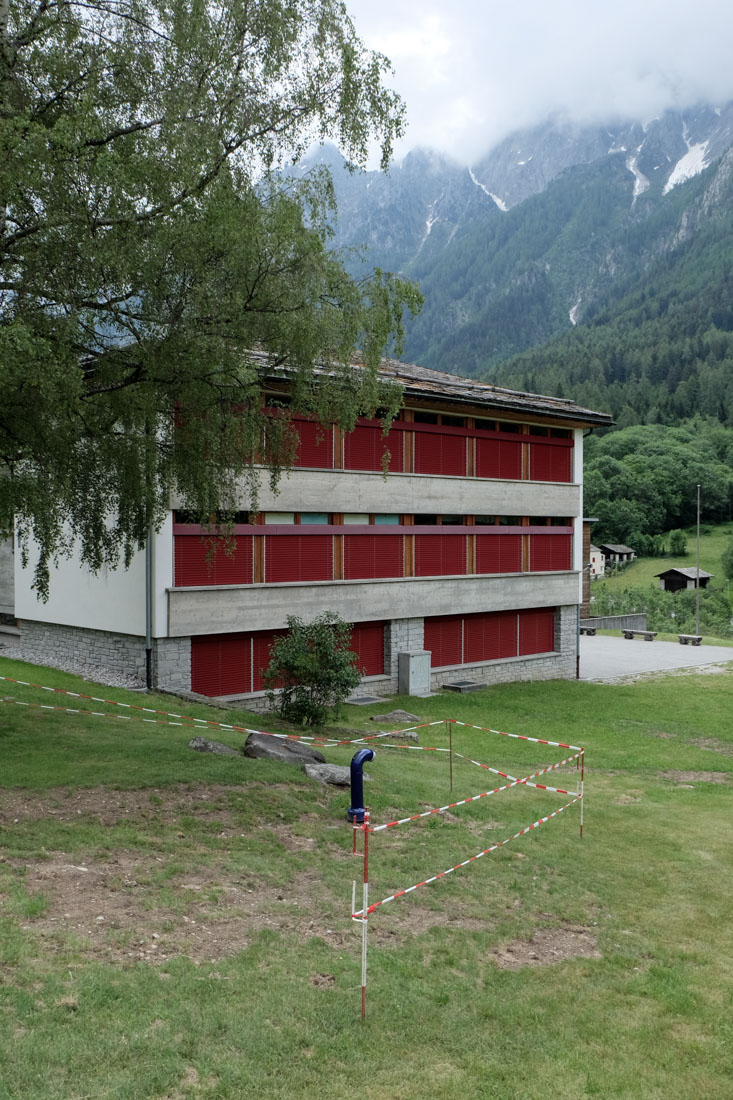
xmin=14 ymin=516 xmax=173 ymax=637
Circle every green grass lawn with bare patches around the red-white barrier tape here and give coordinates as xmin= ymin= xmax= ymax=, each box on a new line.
xmin=0 ymin=659 xmax=733 ymax=1100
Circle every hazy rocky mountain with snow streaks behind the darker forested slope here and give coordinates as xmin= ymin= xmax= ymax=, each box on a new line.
xmin=301 ymin=103 xmax=733 ymax=389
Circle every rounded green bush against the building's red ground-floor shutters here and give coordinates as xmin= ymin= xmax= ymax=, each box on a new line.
xmin=263 ymin=612 xmax=362 ymax=726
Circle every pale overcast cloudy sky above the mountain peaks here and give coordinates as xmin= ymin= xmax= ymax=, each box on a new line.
xmin=347 ymin=0 xmax=733 ymax=162
